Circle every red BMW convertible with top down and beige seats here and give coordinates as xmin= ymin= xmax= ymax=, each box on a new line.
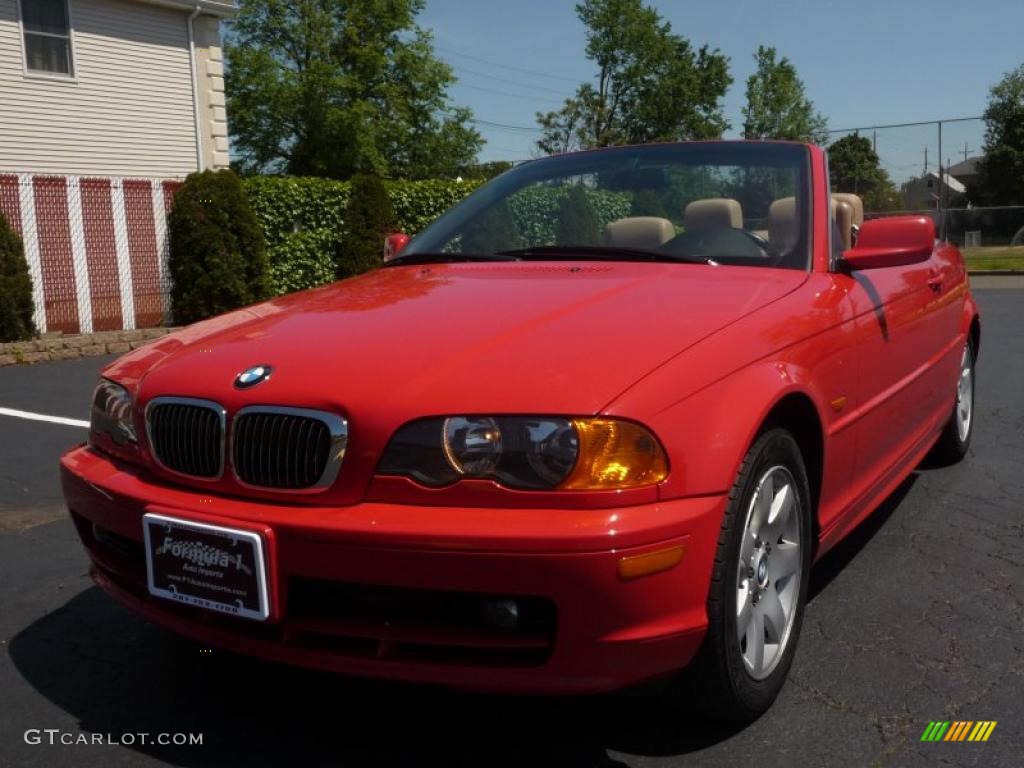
xmin=61 ymin=141 xmax=980 ymax=719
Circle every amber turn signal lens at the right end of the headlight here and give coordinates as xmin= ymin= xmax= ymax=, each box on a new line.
xmin=558 ymin=419 xmax=669 ymax=490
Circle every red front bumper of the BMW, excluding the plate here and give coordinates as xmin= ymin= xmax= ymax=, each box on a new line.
xmin=60 ymin=447 xmax=725 ymax=693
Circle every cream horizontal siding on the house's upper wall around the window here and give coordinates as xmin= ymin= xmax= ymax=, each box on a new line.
xmin=0 ymin=0 xmax=197 ymax=177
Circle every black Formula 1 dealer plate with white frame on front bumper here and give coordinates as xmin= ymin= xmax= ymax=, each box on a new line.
xmin=142 ymin=513 xmax=269 ymax=622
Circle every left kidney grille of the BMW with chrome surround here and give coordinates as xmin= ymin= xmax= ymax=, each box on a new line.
xmin=146 ymin=397 xmax=224 ymax=480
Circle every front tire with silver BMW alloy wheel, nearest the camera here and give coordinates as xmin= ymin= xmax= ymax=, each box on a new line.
xmin=689 ymin=428 xmax=813 ymax=722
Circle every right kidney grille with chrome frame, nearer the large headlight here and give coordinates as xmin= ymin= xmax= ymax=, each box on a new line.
xmin=231 ymin=406 xmax=348 ymax=490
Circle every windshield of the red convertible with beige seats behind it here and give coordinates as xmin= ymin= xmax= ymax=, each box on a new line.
xmin=400 ymin=141 xmax=810 ymax=269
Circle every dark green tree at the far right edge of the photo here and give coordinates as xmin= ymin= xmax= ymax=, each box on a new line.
xmin=969 ymin=65 xmax=1024 ymax=206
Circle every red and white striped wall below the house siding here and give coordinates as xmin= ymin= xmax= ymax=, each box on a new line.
xmin=0 ymin=173 xmax=181 ymax=334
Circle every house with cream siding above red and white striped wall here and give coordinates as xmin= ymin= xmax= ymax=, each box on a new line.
xmin=0 ymin=0 xmax=236 ymax=333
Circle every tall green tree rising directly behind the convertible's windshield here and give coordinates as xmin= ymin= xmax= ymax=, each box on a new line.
xmin=537 ymin=0 xmax=732 ymax=154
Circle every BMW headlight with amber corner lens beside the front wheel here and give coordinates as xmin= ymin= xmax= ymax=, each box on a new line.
xmin=378 ymin=416 xmax=669 ymax=490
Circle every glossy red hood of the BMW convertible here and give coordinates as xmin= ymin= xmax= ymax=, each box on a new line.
xmin=105 ymin=262 xmax=807 ymax=421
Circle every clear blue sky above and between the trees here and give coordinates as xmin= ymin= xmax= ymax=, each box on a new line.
xmin=419 ymin=0 xmax=1024 ymax=180
